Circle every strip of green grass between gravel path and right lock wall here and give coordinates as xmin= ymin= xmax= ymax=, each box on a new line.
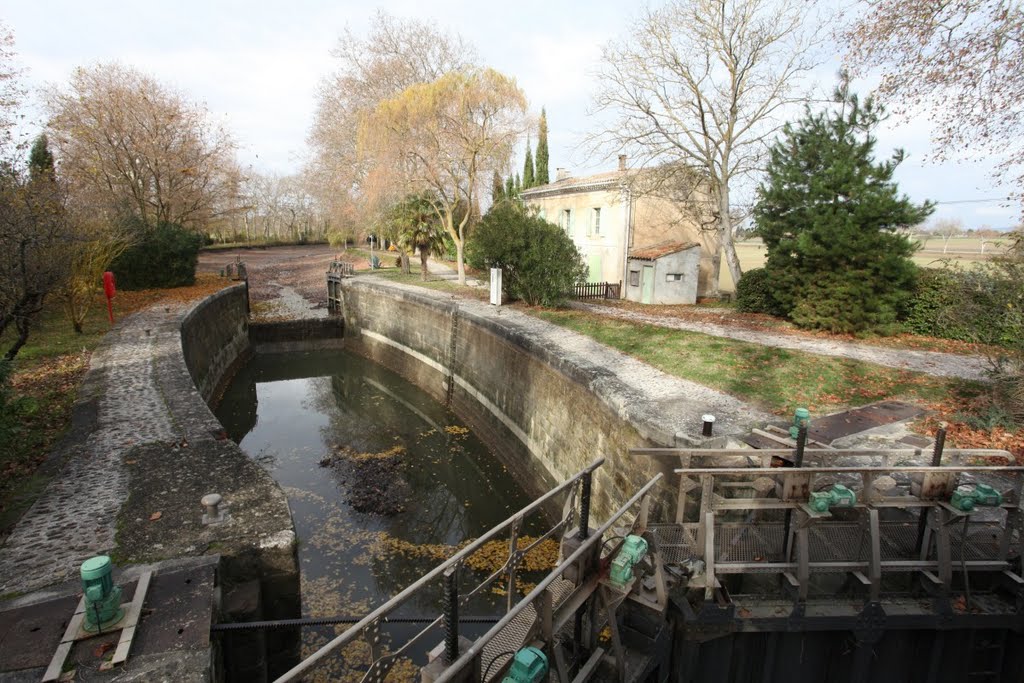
xmin=532 ymin=310 xmax=978 ymax=415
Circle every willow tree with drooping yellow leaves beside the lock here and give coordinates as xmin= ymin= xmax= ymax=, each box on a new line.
xmin=359 ymin=69 xmax=526 ymax=285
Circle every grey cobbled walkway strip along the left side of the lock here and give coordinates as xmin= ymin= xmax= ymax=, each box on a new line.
xmin=0 ymin=306 xmax=182 ymax=594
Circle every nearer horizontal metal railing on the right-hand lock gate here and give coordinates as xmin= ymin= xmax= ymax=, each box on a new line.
xmin=676 ymin=465 xmax=1024 ymax=600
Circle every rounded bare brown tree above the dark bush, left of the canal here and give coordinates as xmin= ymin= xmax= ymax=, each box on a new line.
xmin=46 ymin=63 xmax=237 ymax=235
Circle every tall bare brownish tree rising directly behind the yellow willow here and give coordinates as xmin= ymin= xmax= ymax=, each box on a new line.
xmin=308 ymin=11 xmax=477 ymax=232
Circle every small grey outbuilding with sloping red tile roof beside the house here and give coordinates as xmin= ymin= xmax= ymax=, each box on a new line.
xmin=626 ymin=242 xmax=700 ymax=304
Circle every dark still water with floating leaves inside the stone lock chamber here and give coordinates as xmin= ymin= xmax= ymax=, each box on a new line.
xmin=216 ymin=350 xmax=532 ymax=671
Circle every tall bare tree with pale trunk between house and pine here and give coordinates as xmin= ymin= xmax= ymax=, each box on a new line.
xmin=590 ymin=0 xmax=815 ymax=289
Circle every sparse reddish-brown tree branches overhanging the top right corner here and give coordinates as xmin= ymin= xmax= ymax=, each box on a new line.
xmin=843 ymin=0 xmax=1024 ymax=209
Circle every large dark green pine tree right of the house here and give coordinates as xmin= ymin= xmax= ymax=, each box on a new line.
xmin=754 ymin=78 xmax=934 ymax=333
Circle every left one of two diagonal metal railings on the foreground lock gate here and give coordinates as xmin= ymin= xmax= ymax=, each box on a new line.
xmin=276 ymin=458 xmax=606 ymax=683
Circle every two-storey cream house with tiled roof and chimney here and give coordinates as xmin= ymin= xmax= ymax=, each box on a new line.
xmin=522 ymin=156 xmax=718 ymax=300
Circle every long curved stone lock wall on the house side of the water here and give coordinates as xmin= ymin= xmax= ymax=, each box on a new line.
xmin=343 ymin=279 xmax=761 ymax=517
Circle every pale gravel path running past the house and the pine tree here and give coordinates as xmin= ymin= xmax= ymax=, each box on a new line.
xmin=572 ymin=302 xmax=988 ymax=380
